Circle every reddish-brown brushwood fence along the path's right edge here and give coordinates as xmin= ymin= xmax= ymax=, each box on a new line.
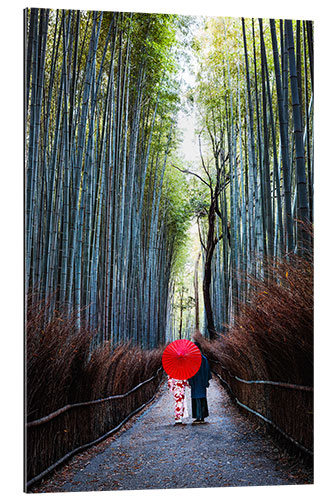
xmin=196 ymin=252 xmax=313 ymax=460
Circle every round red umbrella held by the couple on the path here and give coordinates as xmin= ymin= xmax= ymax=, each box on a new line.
xmin=162 ymin=339 xmax=201 ymax=380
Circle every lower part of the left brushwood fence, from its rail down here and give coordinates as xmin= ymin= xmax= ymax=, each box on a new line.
xmin=26 ymin=367 xmax=163 ymax=487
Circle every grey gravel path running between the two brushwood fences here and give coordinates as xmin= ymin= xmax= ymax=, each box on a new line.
xmin=31 ymin=378 xmax=313 ymax=493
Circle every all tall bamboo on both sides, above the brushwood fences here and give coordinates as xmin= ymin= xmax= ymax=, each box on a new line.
xmin=25 ymin=9 xmax=314 ymax=348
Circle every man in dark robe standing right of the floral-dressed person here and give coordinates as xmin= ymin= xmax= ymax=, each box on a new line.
xmin=188 ymin=342 xmax=212 ymax=424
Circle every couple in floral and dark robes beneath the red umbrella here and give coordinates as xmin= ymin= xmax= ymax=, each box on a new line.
xmin=168 ymin=342 xmax=212 ymax=424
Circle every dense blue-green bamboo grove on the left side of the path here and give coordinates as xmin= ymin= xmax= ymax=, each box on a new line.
xmin=25 ymin=9 xmax=192 ymax=348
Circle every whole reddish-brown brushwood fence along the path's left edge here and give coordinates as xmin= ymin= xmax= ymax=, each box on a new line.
xmin=25 ymin=301 xmax=163 ymax=488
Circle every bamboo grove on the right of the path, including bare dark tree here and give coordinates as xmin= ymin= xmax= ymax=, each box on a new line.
xmin=192 ymin=18 xmax=313 ymax=338
